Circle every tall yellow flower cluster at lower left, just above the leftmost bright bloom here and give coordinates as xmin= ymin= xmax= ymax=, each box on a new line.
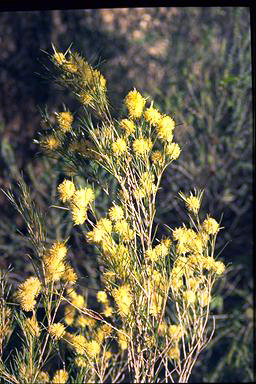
xmin=43 ymin=242 xmax=67 ymax=283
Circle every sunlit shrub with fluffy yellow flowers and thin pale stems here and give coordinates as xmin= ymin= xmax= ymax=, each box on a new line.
xmin=0 ymin=49 xmax=225 ymax=383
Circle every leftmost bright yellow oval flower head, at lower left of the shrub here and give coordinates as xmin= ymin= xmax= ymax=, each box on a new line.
xmin=17 ymin=277 xmax=41 ymax=312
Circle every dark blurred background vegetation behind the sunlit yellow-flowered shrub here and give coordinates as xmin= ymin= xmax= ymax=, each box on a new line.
xmin=0 ymin=7 xmax=253 ymax=382
